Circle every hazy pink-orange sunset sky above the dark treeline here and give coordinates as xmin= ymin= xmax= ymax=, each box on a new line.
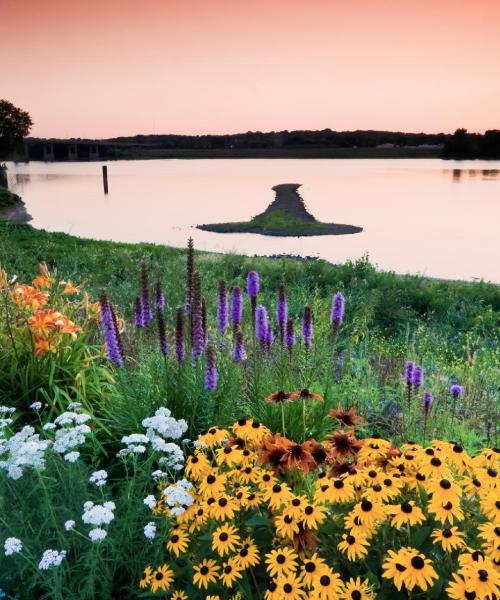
xmin=0 ymin=0 xmax=500 ymax=138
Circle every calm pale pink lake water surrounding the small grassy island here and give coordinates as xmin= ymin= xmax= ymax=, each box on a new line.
xmin=4 ymin=159 xmax=500 ymax=282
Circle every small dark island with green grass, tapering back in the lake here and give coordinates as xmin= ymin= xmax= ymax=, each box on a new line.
xmin=197 ymin=183 xmax=362 ymax=237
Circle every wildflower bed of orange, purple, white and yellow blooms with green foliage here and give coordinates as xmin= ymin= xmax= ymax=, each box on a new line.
xmin=0 ymin=240 xmax=500 ymax=600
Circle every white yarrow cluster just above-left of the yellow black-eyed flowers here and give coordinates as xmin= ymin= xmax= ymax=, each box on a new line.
xmin=118 ymin=407 xmax=187 ymax=476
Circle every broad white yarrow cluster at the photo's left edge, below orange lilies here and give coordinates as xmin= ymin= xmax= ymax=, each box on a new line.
xmin=0 ymin=425 xmax=51 ymax=479
